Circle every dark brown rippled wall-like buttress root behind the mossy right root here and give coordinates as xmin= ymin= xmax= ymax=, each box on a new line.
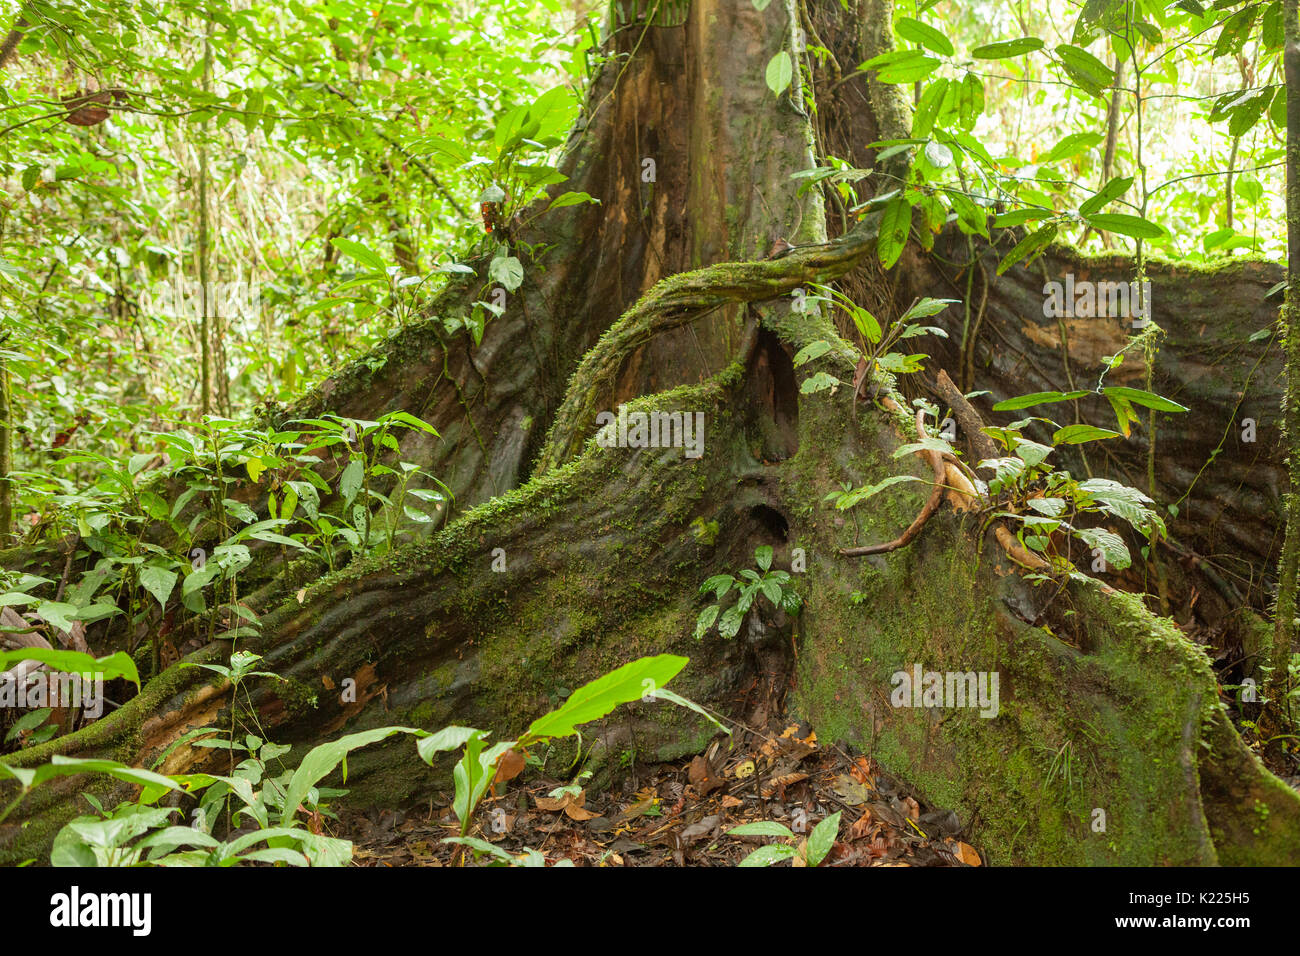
xmin=894 ymin=232 xmax=1287 ymax=676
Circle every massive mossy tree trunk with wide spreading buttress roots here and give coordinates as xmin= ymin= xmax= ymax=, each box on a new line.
xmin=0 ymin=0 xmax=1300 ymax=864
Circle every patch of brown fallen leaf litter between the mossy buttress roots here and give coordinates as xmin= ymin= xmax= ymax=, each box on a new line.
xmin=337 ymin=724 xmax=982 ymax=866
